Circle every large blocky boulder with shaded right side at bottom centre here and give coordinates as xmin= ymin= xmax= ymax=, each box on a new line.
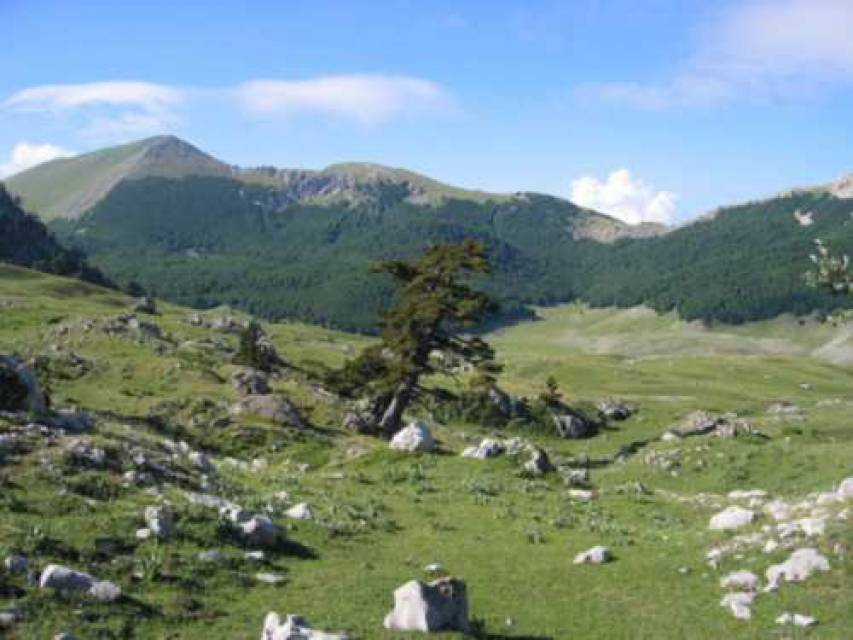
xmin=384 ymin=578 xmax=471 ymax=633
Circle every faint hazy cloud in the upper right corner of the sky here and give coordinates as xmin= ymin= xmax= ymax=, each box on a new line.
xmin=578 ymin=0 xmax=853 ymax=108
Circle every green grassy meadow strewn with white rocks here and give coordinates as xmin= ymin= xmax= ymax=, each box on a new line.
xmin=0 ymin=266 xmax=853 ymax=640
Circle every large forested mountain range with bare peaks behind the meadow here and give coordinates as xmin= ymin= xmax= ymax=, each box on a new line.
xmin=9 ymin=136 xmax=853 ymax=330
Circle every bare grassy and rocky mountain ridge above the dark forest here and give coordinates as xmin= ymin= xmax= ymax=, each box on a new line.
xmin=6 ymin=135 xmax=667 ymax=242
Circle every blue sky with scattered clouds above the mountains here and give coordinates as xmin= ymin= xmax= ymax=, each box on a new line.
xmin=0 ymin=0 xmax=853 ymax=222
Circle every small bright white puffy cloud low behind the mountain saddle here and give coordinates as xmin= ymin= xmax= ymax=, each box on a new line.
xmin=570 ymin=169 xmax=677 ymax=224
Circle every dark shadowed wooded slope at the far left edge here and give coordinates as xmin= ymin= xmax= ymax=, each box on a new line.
xmin=0 ymin=184 xmax=108 ymax=284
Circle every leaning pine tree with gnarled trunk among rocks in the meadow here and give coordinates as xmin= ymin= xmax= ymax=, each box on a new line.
xmin=339 ymin=240 xmax=500 ymax=438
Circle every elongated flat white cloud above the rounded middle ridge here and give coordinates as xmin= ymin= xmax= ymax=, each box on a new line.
xmin=237 ymin=75 xmax=453 ymax=125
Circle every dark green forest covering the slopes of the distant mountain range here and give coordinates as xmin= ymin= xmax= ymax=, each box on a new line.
xmin=53 ymin=177 xmax=853 ymax=331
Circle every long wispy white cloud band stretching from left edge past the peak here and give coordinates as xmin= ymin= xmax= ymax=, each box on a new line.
xmin=0 ymin=74 xmax=456 ymax=142
